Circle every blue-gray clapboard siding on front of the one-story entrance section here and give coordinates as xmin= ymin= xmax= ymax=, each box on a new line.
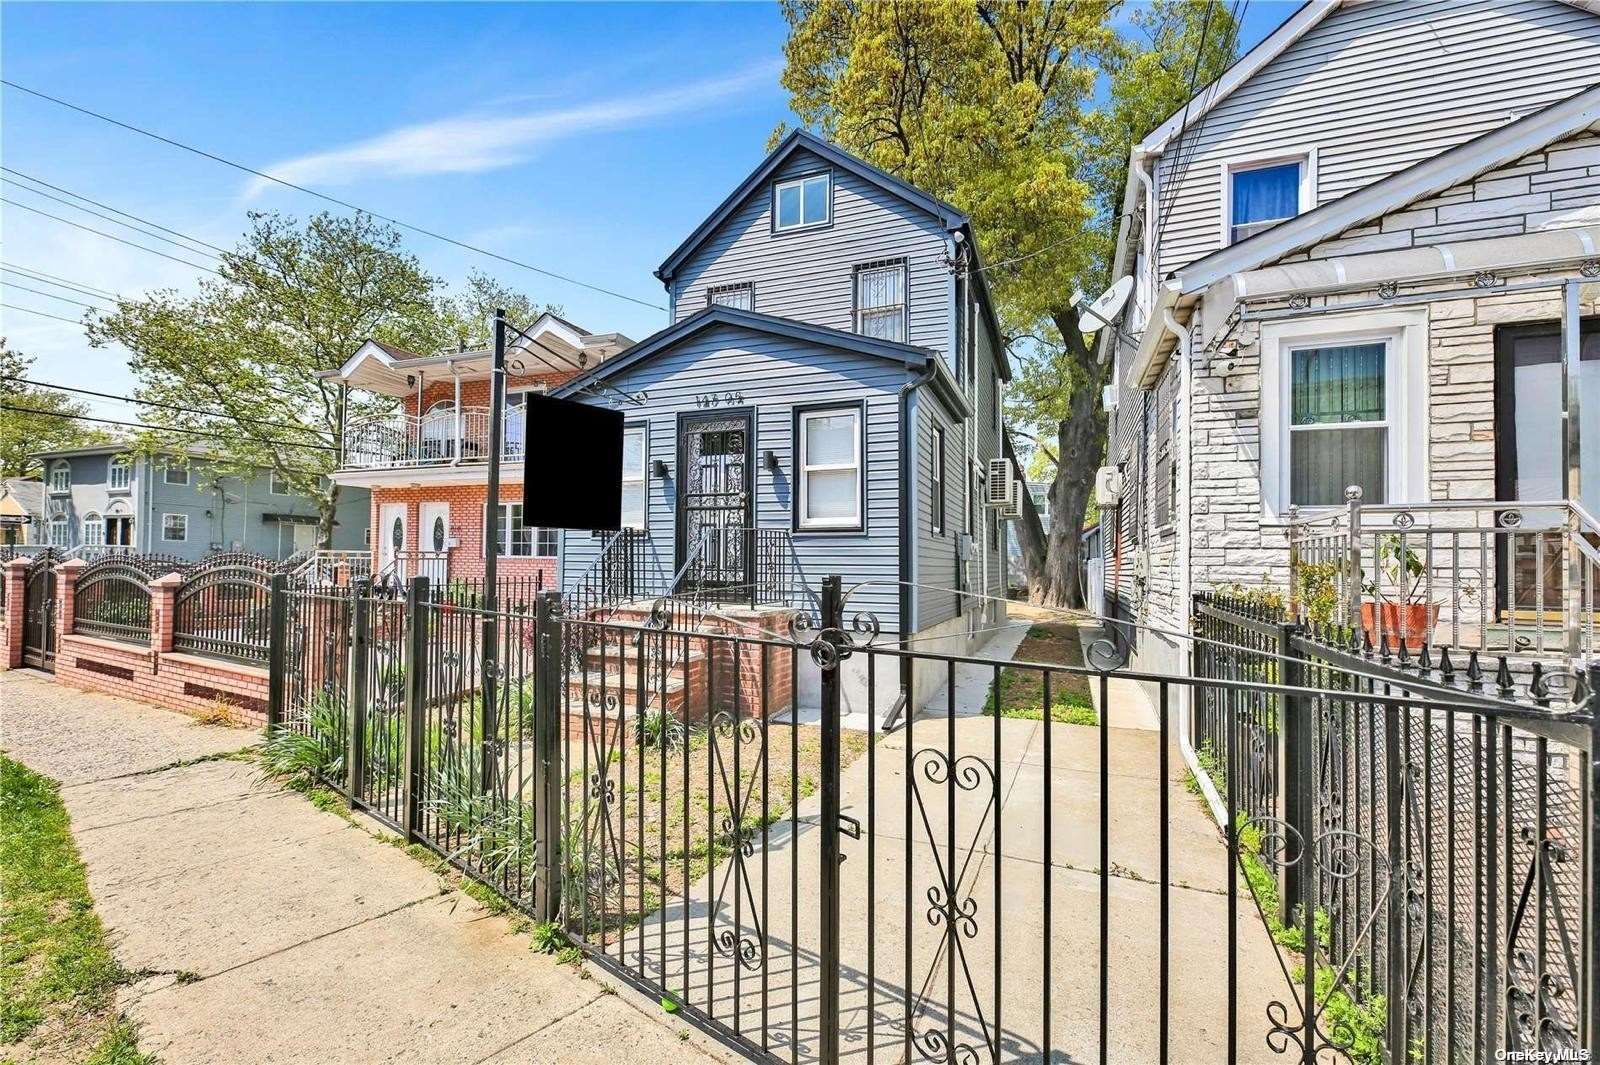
xmin=562 ymin=326 xmax=907 ymax=630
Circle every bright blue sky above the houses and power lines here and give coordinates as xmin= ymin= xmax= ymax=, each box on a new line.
xmin=0 ymin=0 xmax=1298 ymax=417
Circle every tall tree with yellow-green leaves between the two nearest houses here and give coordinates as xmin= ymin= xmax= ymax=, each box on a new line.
xmin=782 ymin=0 xmax=1237 ymax=606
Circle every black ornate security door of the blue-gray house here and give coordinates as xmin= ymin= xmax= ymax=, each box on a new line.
xmin=677 ymin=411 xmax=754 ymax=592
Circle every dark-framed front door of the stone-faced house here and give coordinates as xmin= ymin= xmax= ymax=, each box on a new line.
xmin=1494 ymin=318 xmax=1600 ymax=617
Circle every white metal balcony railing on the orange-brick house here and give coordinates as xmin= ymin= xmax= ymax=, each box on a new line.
xmin=341 ymin=406 xmax=523 ymax=470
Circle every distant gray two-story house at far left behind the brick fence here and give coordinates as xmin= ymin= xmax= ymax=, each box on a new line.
xmin=34 ymin=445 xmax=368 ymax=560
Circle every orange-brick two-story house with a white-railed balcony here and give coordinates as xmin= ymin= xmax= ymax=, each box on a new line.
xmin=320 ymin=313 xmax=632 ymax=587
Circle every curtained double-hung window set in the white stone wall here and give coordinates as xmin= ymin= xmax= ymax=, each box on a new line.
xmin=1288 ymin=341 xmax=1394 ymax=507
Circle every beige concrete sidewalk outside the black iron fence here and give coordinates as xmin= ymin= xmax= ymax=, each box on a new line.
xmin=0 ymin=672 xmax=733 ymax=1065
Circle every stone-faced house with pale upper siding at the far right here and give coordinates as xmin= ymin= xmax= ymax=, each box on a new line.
xmin=1102 ymin=0 xmax=1600 ymax=667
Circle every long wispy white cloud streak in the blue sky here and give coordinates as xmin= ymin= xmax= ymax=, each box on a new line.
xmin=243 ymin=62 xmax=781 ymax=200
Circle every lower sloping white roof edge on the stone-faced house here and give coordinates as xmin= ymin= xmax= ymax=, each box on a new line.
xmin=1176 ymin=85 xmax=1600 ymax=293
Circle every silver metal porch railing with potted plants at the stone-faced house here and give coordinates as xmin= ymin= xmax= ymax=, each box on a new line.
xmin=1288 ymin=486 xmax=1600 ymax=659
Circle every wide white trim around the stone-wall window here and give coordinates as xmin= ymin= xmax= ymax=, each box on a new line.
xmin=1261 ymin=309 xmax=1430 ymax=523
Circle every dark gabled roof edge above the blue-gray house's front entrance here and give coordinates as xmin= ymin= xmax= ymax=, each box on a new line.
xmin=550 ymin=304 xmax=973 ymax=417
